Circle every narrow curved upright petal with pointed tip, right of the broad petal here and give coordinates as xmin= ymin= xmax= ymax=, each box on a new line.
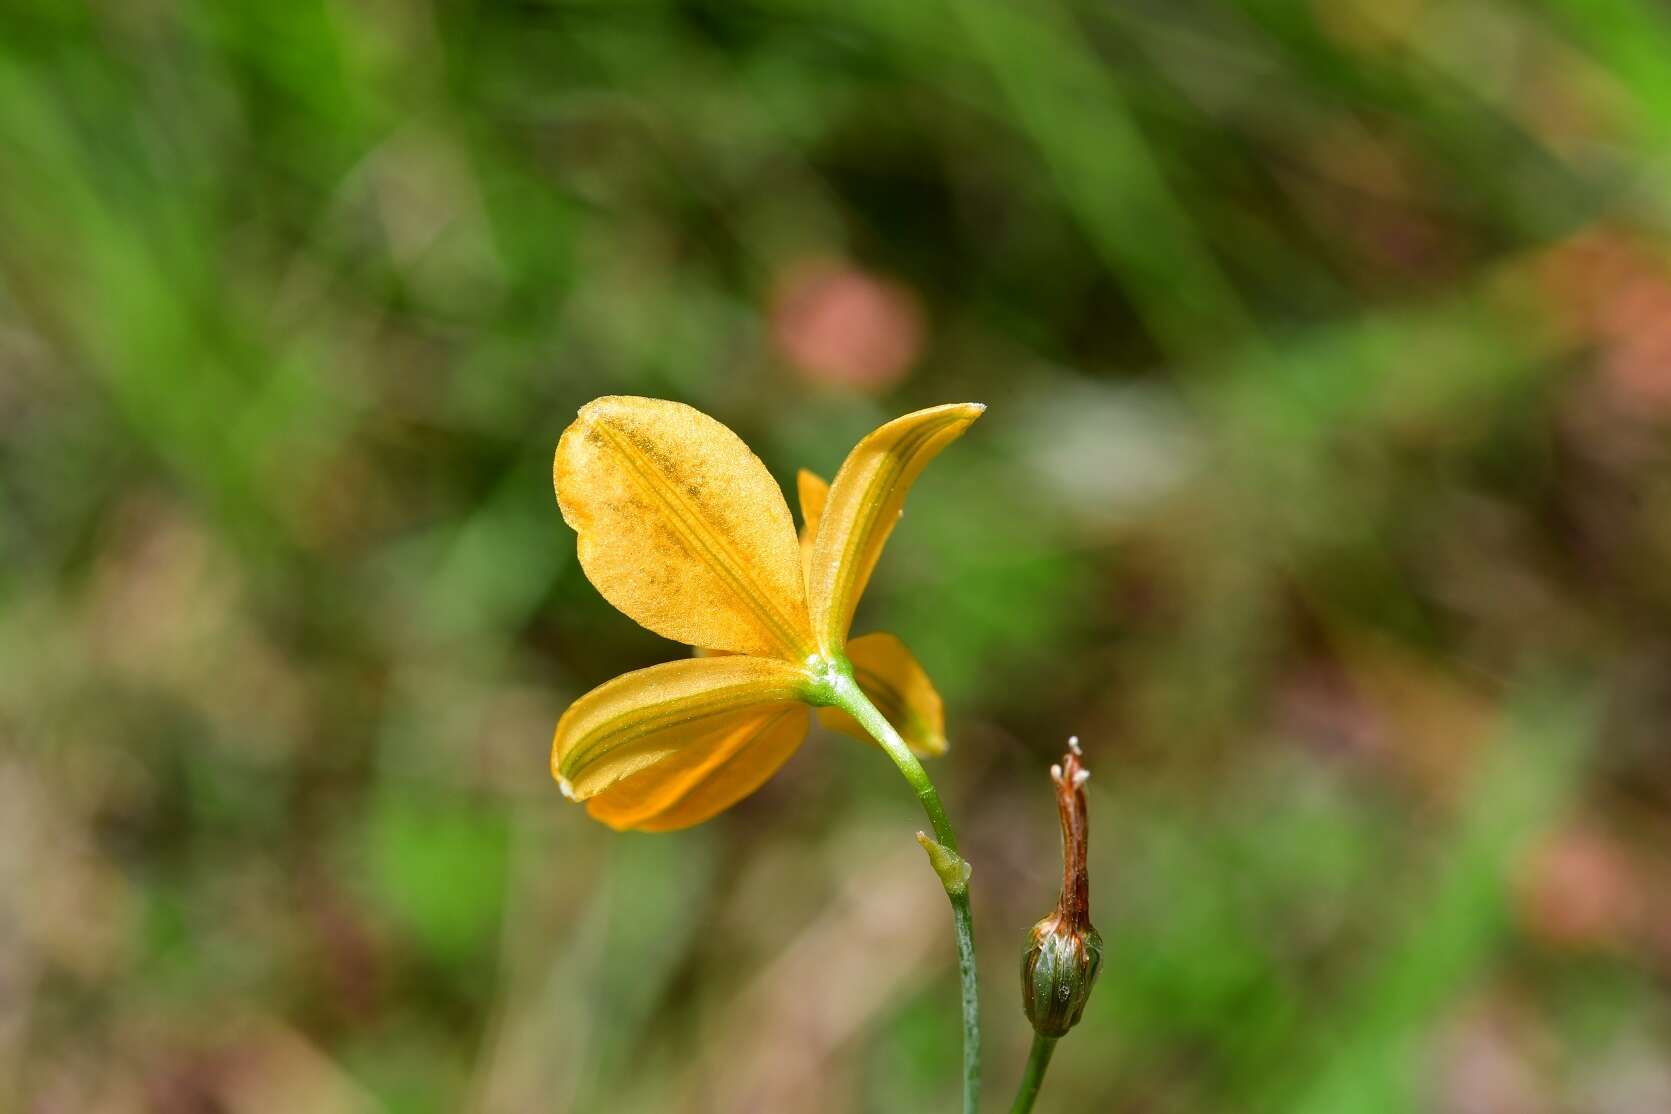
xmin=807 ymin=403 xmax=986 ymax=651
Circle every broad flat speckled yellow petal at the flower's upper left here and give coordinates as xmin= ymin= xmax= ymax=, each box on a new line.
xmin=551 ymin=396 xmax=814 ymax=661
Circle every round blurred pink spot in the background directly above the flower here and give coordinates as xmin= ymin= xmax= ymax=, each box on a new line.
xmin=770 ymin=261 xmax=922 ymax=392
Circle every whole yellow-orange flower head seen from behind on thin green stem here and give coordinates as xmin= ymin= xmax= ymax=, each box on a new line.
xmin=551 ymin=396 xmax=986 ymax=832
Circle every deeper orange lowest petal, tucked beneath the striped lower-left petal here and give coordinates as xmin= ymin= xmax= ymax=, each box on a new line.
xmin=587 ymin=703 xmax=812 ymax=832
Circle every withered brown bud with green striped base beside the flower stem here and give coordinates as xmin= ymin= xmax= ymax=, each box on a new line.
xmin=1021 ymin=737 xmax=1103 ymax=1037
